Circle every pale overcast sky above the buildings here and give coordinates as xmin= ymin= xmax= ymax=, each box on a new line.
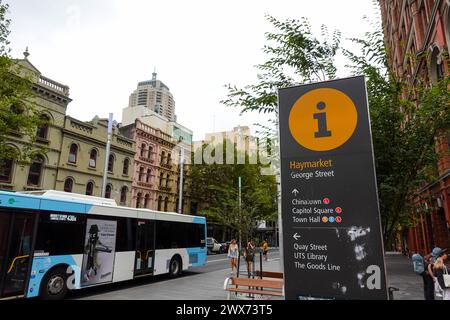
xmin=4 ymin=0 xmax=378 ymax=140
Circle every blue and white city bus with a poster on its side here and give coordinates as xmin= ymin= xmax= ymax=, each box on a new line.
xmin=0 ymin=190 xmax=207 ymax=300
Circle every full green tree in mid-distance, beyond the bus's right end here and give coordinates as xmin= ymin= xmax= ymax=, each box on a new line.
xmin=189 ymin=140 xmax=277 ymax=245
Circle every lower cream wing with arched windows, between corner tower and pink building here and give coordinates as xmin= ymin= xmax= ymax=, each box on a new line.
xmin=55 ymin=116 xmax=134 ymax=206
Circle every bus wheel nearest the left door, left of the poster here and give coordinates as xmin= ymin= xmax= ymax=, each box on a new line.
xmin=40 ymin=268 xmax=68 ymax=300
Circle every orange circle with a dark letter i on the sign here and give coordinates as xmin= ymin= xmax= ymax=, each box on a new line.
xmin=289 ymin=88 xmax=358 ymax=151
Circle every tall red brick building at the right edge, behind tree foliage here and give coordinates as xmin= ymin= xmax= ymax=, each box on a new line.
xmin=379 ymin=0 xmax=450 ymax=254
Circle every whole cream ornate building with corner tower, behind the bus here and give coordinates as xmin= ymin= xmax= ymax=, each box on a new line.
xmin=0 ymin=50 xmax=134 ymax=206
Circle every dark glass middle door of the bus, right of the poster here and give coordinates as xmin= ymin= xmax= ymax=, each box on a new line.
xmin=134 ymin=221 xmax=155 ymax=277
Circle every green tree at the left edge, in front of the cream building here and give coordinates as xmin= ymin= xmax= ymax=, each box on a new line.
xmin=0 ymin=0 xmax=45 ymax=165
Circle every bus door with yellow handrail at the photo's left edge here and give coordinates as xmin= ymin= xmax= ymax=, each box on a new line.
xmin=0 ymin=212 xmax=35 ymax=298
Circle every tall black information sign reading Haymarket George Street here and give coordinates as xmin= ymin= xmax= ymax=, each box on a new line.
xmin=279 ymin=77 xmax=388 ymax=300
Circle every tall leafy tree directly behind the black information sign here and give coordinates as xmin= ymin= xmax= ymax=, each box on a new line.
xmin=223 ymin=16 xmax=450 ymax=247
